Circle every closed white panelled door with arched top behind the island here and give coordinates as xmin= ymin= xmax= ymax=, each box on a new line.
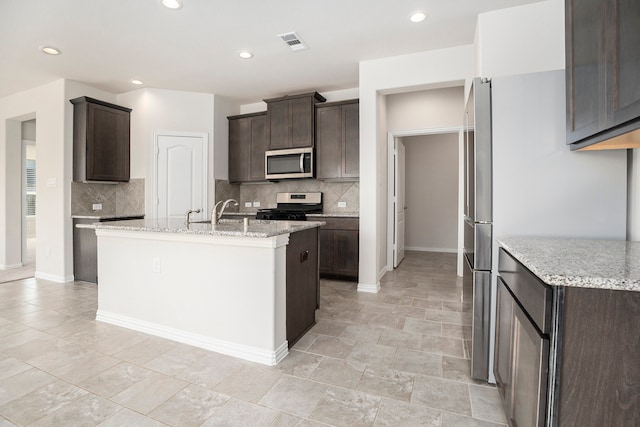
xmin=154 ymin=132 xmax=208 ymax=220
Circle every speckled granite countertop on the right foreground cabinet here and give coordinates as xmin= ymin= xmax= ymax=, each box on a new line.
xmin=497 ymin=237 xmax=640 ymax=292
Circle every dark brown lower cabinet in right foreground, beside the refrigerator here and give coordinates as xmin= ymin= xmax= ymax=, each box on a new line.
xmin=494 ymin=249 xmax=640 ymax=427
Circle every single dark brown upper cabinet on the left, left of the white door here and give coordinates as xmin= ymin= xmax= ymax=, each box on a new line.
xmin=70 ymin=96 xmax=131 ymax=182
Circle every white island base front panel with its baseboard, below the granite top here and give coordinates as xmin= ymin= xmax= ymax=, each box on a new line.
xmin=96 ymin=227 xmax=289 ymax=365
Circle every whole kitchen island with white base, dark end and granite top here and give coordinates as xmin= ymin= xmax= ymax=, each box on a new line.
xmin=95 ymin=219 xmax=323 ymax=365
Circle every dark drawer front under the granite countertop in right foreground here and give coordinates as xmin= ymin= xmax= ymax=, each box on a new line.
xmin=498 ymin=248 xmax=552 ymax=334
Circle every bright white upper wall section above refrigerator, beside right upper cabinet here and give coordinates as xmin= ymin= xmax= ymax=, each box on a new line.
xmin=474 ymin=0 xmax=565 ymax=77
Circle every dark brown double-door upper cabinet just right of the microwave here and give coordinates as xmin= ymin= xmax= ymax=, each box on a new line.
xmin=316 ymin=99 xmax=360 ymax=180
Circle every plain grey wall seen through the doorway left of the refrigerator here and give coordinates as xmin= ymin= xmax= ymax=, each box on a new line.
xmin=402 ymin=135 xmax=462 ymax=252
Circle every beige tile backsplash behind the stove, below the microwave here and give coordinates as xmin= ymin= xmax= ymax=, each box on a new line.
xmin=216 ymin=179 xmax=360 ymax=214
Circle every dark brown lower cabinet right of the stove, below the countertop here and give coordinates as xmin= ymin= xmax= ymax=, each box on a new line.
xmin=320 ymin=218 xmax=360 ymax=280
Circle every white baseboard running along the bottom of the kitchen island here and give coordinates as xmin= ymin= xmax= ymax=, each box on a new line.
xmin=96 ymin=310 xmax=289 ymax=366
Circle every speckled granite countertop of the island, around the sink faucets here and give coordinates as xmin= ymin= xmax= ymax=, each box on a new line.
xmin=87 ymin=218 xmax=324 ymax=238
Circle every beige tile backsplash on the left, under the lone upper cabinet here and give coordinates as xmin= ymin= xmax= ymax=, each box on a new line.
xmin=71 ymin=178 xmax=144 ymax=215
